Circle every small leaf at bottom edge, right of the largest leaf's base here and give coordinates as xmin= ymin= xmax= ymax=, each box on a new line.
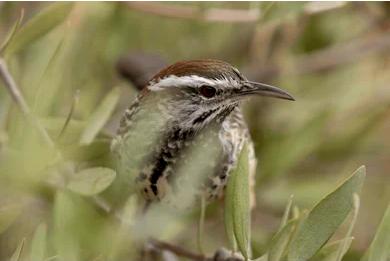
xmin=310 ymin=237 xmax=353 ymax=261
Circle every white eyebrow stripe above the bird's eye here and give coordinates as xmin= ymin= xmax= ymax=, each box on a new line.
xmin=147 ymin=75 xmax=238 ymax=91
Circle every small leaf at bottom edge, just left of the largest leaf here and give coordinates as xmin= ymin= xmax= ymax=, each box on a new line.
xmin=268 ymin=219 xmax=299 ymax=261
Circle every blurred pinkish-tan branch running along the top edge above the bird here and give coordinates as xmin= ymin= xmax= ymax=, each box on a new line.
xmin=126 ymin=2 xmax=261 ymax=23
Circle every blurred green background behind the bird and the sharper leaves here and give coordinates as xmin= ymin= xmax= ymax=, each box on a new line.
xmin=0 ymin=2 xmax=390 ymax=260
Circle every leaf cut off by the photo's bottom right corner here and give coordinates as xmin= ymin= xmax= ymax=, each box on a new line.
xmin=362 ymin=204 xmax=390 ymax=261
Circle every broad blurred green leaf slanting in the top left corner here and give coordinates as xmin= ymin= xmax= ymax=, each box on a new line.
xmin=6 ymin=2 xmax=73 ymax=55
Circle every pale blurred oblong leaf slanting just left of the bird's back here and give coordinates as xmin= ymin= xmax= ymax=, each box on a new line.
xmin=80 ymin=88 xmax=120 ymax=145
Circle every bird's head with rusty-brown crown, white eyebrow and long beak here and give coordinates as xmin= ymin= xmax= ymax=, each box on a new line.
xmin=147 ymin=60 xmax=294 ymax=128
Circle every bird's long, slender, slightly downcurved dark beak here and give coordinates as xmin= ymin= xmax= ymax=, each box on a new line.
xmin=239 ymin=81 xmax=295 ymax=101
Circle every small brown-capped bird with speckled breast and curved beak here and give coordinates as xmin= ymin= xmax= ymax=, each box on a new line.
xmin=111 ymin=59 xmax=294 ymax=205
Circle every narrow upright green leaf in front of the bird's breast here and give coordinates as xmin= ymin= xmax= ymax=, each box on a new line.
xmin=225 ymin=144 xmax=250 ymax=259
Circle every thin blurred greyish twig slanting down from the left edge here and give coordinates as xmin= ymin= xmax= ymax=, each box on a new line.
xmin=0 ymin=57 xmax=55 ymax=148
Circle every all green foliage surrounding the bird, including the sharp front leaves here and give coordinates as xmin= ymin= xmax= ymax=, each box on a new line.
xmin=0 ymin=2 xmax=390 ymax=261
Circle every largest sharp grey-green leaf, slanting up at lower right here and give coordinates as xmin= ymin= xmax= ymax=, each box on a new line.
xmin=288 ymin=166 xmax=366 ymax=261
